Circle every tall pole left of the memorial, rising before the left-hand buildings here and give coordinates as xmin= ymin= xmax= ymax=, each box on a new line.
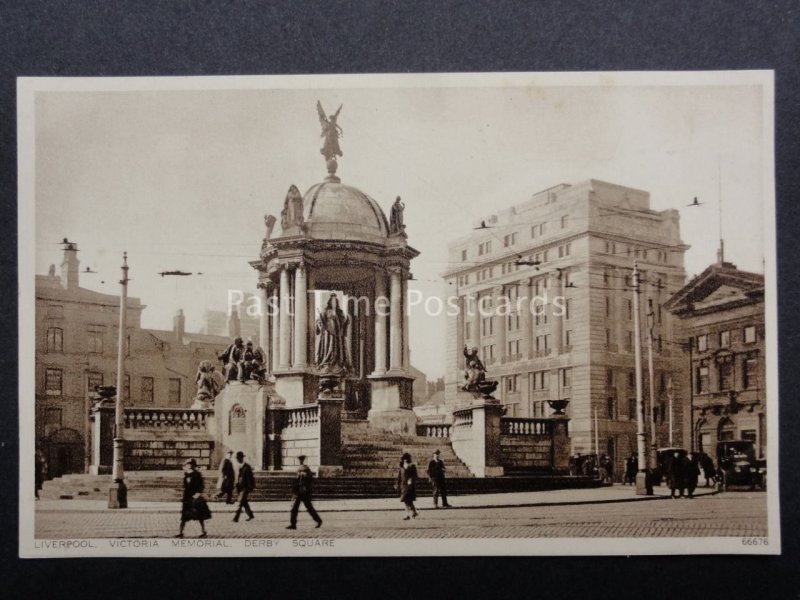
xmin=108 ymin=252 xmax=128 ymax=508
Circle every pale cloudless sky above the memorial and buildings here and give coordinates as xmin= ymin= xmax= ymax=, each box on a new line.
xmin=29 ymin=75 xmax=773 ymax=378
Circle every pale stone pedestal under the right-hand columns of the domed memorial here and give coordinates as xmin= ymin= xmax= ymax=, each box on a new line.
xmin=367 ymin=375 xmax=417 ymax=435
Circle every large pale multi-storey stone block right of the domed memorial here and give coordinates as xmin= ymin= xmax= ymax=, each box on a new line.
xmin=445 ymin=180 xmax=688 ymax=472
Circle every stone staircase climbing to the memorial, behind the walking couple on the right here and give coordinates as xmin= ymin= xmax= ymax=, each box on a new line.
xmin=342 ymin=421 xmax=473 ymax=479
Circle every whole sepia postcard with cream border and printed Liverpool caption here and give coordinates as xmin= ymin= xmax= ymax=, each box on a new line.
xmin=17 ymin=71 xmax=780 ymax=558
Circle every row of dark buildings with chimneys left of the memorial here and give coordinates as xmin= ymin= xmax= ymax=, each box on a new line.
xmin=35 ymin=244 xmax=230 ymax=477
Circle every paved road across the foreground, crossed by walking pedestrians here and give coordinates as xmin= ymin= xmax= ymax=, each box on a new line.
xmin=35 ymin=486 xmax=767 ymax=539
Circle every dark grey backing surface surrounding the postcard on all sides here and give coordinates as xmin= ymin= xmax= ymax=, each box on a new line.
xmin=0 ymin=0 xmax=800 ymax=600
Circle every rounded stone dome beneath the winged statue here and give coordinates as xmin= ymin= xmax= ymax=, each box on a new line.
xmin=303 ymin=178 xmax=389 ymax=244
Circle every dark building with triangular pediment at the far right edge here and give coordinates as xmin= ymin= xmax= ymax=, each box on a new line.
xmin=666 ymin=262 xmax=767 ymax=457
